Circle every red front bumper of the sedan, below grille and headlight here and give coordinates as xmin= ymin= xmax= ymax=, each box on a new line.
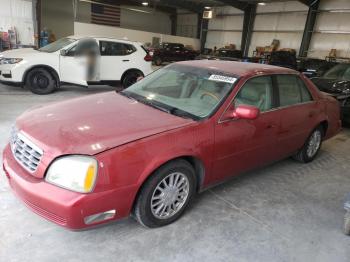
xmin=3 ymin=146 xmax=136 ymax=230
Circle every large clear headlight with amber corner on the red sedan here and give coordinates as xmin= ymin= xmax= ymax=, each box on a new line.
xmin=45 ymin=155 xmax=97 ymax=193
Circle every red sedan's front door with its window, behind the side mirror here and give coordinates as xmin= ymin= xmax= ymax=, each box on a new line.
xmin=214 ymin=76 xmax=281 ymax=181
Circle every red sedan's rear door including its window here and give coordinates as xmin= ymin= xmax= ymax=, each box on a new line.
xmin=274 ymin=75 xmax=320 ymax=156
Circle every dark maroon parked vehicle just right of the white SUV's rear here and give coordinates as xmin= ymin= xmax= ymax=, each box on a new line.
xmin=153 ymin=43 xmax=199 ymax=66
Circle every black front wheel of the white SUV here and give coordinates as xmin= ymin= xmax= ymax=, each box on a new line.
xmin=25 ymin=68 xmax=57 ymax=95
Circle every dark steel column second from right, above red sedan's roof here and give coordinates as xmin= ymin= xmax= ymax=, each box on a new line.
xmin=241 ymin=4 xmax=256 ymax=56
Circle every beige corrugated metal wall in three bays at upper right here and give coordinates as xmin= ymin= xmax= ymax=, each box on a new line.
xmin=206 ymin=0 xmax=350 ymax=58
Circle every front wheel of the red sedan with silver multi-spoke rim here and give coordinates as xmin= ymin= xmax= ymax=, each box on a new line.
xmin=134 ymin=160 xmax=195 ymax=228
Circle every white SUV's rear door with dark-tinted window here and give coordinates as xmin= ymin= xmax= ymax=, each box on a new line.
xmin=99 ymin=40 xmax=136 ymax=81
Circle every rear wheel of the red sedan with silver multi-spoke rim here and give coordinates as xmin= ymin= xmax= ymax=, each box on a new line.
xmin=293 ymin=127 xmax=323 ymax=163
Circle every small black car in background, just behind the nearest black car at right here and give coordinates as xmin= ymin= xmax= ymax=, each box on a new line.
xmin=298 ymin=58 xmax=338 ymax=78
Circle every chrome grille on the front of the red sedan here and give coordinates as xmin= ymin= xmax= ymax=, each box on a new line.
xmin=11 ymin=130 xmax=43 ymax=173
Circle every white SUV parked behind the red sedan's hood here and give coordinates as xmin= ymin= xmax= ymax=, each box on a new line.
xmin=0 ymin=36 xmax=152 ymax=94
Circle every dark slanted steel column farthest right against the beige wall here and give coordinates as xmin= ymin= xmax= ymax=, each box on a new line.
xmin=299 ymin=0 xmax=320 ymax=57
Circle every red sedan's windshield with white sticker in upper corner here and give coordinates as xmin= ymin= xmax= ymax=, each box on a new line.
xmin=122 ymin=64 xmax=237 ymax=120
